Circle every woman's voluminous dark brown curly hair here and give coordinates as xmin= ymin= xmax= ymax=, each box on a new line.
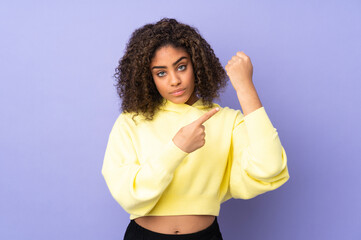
xmin=114 ymin=18 xmax=227 ymax=123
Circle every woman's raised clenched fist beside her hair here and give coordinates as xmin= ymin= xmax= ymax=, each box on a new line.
xmin=225 ymin=52 xmax=253 ymax=91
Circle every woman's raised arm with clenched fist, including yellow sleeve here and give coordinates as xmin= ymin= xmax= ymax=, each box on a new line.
xmin=224 ymin=52 xmax=290 ymax=200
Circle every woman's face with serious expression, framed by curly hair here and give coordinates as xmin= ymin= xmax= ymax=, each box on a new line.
xmin=150 ymin=46 xmax=198 ymax=105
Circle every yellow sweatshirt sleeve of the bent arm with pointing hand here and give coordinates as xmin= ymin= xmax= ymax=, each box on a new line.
xmin=101 ymin=118 xmax=188 ymax=216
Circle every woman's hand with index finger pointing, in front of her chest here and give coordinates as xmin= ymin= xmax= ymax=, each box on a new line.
xmin=173 ymin=107 xmax=219 ymax=153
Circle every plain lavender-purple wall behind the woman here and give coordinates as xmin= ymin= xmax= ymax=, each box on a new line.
xmin=0 ymin=0 xmax=361 ymax=240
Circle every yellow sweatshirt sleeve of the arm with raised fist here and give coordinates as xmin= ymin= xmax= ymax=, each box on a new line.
xmin=224 ymin=106 xmax=290 ymax=201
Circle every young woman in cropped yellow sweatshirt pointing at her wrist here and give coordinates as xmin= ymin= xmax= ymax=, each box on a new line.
xmin=102 ymin=18 xmax=289 ymax=240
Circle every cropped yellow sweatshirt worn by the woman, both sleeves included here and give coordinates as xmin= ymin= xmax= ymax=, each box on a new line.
xmin=102 ymin=98 xmax=290 ymax=220
